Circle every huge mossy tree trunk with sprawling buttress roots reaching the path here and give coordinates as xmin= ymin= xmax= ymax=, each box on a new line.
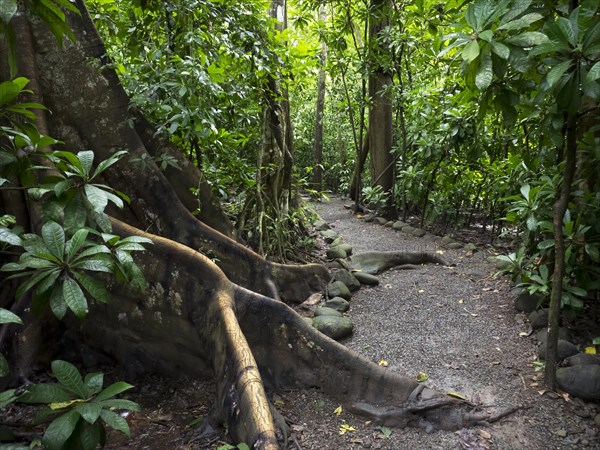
xmin=2 ymin=1 xmax=516 ymax=449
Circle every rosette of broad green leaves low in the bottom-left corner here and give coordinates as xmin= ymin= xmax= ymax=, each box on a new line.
xmin=0 ymin=360 xmax=140 ymax=450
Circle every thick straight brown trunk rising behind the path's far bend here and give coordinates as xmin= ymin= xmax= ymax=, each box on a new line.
xmin=369 ymin=0 xmax=395 ymax=218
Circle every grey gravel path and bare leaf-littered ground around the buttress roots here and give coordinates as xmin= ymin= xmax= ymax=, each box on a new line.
xmin=2 ymin=198 xmax=600 ymax=450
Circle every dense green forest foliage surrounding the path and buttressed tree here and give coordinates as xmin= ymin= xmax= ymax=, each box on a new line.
xmin=0 ymin=0 xmax=600 ymax=448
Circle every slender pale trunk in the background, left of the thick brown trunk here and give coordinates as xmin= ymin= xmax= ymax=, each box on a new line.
xmin=313 ymin=5 xmax=327 ymax=191
